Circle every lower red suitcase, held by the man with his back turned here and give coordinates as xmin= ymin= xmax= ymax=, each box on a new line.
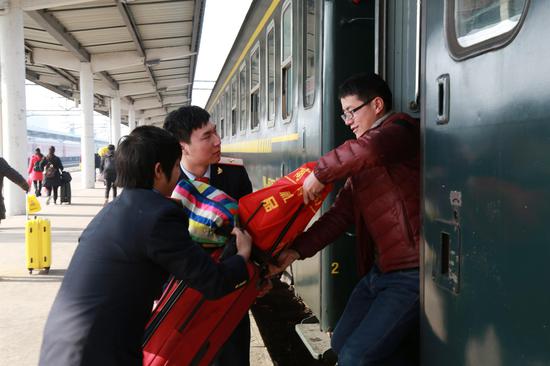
xmin=143 ymin=252 xmax=259 ymax=366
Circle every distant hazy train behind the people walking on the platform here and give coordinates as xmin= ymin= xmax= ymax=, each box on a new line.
xmin=27 ymin=130 xmax=109 ymax=167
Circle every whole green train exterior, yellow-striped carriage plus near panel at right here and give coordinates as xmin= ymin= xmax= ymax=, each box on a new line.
xmin=207 ymin=0 xmax=550 ymax=366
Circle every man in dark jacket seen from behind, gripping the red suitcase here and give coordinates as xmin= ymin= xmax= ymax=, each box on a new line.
xmin=39 ymin=126 xmax=252 ymax=366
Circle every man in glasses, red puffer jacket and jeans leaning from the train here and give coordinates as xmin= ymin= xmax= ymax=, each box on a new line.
xmin=271 ymin=73 xmax=420 ymax=366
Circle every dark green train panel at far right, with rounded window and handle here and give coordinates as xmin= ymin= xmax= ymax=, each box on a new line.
xmin=421 ymin=0 xmax=550 ymax=366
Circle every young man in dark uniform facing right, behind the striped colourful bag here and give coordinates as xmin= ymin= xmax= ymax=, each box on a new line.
xmin=164 ymin=106 xmax=252 ymax=366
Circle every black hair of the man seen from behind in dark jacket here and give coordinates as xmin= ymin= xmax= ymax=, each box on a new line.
xmin=115 ymin=126 xmax=181 ymax=189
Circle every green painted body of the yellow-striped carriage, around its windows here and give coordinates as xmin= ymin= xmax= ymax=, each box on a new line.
xmin=207 ymin=0 xmax=374 ymax=330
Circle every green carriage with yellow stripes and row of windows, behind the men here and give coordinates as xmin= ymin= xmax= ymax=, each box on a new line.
xmin=207 ymin=0 xmax=417 ymax=356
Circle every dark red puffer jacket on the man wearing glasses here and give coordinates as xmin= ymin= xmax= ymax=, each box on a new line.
xmin=292 ymin=113 xmax=420 ymax=275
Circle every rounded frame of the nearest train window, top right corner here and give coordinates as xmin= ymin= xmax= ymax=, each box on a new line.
xmin=444 ymin=0 xmax=531 ymax=61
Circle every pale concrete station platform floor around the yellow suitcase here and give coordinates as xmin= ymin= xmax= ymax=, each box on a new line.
xmin=0 ymin=172 xmax=273 ymax=366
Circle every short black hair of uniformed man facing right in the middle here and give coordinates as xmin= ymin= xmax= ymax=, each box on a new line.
xmin=163 ymin=105 xmax=210 ymax=144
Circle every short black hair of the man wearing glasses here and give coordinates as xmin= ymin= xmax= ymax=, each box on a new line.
xmin=338 ymin=72 xmax=393 ymax=111
